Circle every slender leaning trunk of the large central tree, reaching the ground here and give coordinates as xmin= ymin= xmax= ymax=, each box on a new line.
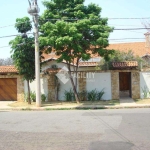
xmin=67 ymin=64 xmax=80 ymax=103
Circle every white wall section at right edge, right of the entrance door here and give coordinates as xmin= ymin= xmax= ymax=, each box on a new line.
xmin=140 ymin=72 xmax=150 ymax=98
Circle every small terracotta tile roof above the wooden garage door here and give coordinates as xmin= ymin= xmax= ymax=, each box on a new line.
xmin=0 ymin=66 xmax=18 ymax=74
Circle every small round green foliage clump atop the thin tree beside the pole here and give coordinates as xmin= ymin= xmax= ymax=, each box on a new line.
xmin=15 ymin=17 xmax=32 ymax=33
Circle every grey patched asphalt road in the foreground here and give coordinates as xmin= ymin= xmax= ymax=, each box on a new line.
xmin=0 ymin=108 xmax=150 ymax=150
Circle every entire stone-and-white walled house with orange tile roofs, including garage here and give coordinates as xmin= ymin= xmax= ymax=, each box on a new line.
xmin=0 ymin=42 xmax=150 ymax=101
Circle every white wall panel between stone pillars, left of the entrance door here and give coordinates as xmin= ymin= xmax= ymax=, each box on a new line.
xmin=86 ymin=73 xmax=112 ymax=100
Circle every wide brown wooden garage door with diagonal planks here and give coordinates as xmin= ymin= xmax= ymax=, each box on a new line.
xmin=0 ymin=78 xmax=17 ymax=101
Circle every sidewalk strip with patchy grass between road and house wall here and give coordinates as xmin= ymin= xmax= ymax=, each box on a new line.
xmin=0 ymin=101 xmax=150 ymax=111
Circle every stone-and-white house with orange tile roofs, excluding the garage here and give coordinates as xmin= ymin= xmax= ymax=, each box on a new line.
xmin=25 ymin=42 xmax=150 ymax=101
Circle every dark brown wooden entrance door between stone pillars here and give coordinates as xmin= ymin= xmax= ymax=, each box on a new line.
xmin=119 ymin=72 xmax=131 ymax=97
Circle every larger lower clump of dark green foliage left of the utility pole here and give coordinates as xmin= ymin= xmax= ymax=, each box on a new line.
xmin=9 ymin=36 xmax=35 ymax=82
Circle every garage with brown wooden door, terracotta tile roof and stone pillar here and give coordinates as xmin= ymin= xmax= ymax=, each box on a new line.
xmin=0 ymin=66 xmax=24 ymax=101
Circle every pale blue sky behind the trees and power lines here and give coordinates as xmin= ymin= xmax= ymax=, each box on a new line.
xmin=0 ymin=0 xmax=150 ymax=58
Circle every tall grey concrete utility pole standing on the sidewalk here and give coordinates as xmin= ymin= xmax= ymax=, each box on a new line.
xmin=28 ymin=0 xmax=41 ymax=107
